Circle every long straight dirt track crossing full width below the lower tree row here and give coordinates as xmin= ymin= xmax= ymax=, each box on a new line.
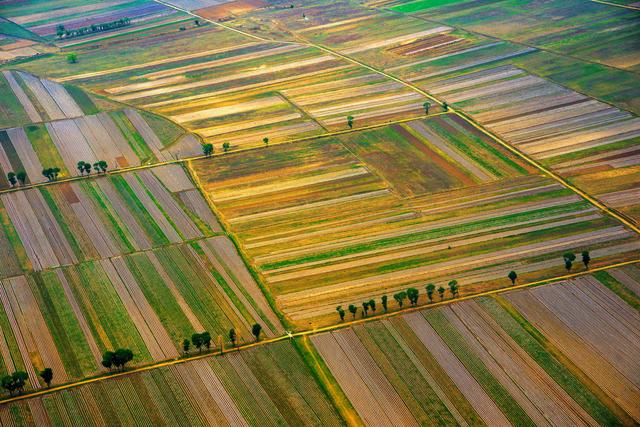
xmin=0 ymin=258 xmax=640 ymax=405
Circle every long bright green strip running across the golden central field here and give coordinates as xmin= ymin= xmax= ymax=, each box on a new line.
xmin=261 ymin=201 xmax=585 ymax=271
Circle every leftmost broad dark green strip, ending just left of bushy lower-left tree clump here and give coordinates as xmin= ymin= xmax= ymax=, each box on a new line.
xmin=28 ymin=271 xmax=98 ymax=378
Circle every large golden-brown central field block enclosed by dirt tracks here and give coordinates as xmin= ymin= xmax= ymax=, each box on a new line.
xmin=190 ymin=116 xmax=640 ymax=325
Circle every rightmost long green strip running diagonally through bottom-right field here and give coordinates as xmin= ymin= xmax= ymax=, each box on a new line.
xmin=478 ymin=296 xmax=620 ymax=426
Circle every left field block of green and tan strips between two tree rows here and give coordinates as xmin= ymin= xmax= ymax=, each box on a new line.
xmin=0 ymin=165 xmax=282 ymax=387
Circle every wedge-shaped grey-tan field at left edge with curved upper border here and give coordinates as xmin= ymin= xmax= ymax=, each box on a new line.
xmin=0 ymin=71 xmax=202 ymax=189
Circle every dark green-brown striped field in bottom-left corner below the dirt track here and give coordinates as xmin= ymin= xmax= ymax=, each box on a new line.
xmin=0 ymin=342 xmax=343 ymax=426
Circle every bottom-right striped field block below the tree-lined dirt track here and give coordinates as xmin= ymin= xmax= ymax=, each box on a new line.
xmin=311 ymin=266 xmax=640 ymax=426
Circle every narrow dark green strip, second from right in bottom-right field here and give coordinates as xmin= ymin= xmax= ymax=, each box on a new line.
xmin=422 ymin=310 xmax=535 ymax=427
